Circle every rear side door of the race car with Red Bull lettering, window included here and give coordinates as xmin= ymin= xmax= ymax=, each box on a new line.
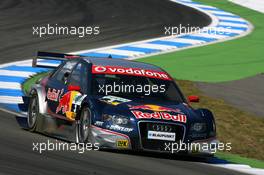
xmin=45 ymin=59 xmax=79 ymax=119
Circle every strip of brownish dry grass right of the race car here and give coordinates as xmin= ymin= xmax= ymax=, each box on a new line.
xmin=177 ymin=80 xmax=264 ymax=164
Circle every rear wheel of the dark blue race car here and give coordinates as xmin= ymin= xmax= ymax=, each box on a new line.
xmin=27 ymin=93 xmax=39 ymax=132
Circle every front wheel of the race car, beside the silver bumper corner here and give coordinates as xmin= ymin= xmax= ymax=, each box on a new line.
xmin=77 ymin=106 xmax=91 ymax=143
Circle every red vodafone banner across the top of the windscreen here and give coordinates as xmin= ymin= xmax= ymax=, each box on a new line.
xmin=92 ymin=66 xmax=172 ymax=80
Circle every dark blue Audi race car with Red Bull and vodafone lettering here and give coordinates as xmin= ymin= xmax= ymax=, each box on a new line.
xmin=19 ymin=52 xmax=217 ymax=153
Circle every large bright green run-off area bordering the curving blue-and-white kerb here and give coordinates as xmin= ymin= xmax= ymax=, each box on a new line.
xmin=138 ymin=0 xmax=264 ymax=82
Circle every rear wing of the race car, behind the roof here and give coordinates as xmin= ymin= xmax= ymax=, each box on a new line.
xmin=32 ymin=52 xmax=81 ymax=68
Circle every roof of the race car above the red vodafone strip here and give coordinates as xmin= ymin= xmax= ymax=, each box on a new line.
xmin=84 ymin=57 xmax=164 ymax=72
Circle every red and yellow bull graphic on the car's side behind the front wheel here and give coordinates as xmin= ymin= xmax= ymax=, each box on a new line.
xmin=56 ymin=91 xmax=86 ymax=120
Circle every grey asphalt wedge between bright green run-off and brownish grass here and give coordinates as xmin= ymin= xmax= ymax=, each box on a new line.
xmin=197 ymin=74 xmax=264 ymax=117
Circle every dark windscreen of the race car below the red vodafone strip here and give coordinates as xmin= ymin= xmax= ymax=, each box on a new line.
xmin=92 ymin=74 xmax=184 ymax=103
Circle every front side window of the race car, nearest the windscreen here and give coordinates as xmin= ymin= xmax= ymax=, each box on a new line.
xmin=68 ymin=63 xmax=88 ymax=92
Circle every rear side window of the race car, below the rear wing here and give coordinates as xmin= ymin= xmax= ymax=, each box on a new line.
xmin=53 ymin=60 xmax=78 ymax=82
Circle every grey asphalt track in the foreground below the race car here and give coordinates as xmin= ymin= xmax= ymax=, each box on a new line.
xmin=0 ymin=113 xmax=250 ymax=175
